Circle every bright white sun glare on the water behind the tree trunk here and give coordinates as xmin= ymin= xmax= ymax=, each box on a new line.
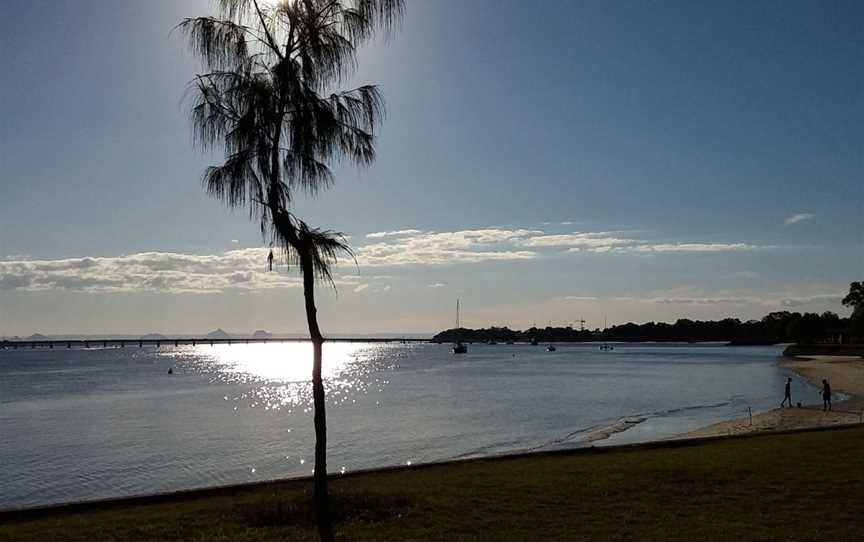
xmin=163 ymin=342 xmax=405 ymax=412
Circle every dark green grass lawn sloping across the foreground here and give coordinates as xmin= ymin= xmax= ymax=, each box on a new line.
xmin=0 ymin=428 xmax=864 ymax=542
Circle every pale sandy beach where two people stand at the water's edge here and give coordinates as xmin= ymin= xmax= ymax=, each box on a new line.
xmin=681 ymin=356 xmax=864 ymax=438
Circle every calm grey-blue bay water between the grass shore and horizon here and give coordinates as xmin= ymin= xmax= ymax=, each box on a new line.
xmin=0 ymin=343 xmax=817 ymax=508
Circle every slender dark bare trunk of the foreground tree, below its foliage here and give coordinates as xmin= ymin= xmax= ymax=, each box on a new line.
xmin=300 ymin=250 xmax=335 ymax=542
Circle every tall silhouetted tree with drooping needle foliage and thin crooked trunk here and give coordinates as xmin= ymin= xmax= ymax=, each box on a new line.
xmin=178 ymin=0 xmax=404 ymax=541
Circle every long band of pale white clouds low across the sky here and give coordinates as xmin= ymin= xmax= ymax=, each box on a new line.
xmin=0 ymin=228 xmax=769 ymax=293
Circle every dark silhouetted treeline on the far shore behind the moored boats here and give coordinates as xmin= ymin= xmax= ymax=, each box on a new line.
xmin=432 ymin=311 xmax=850 ymax=344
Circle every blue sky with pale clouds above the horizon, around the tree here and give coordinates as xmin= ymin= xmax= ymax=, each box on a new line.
xmin=0 ymin=0 xmax=864 ymax=336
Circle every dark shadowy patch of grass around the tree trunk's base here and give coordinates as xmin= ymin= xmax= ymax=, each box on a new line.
xmin=238 ymin=490 xmax=412 ymax=527
